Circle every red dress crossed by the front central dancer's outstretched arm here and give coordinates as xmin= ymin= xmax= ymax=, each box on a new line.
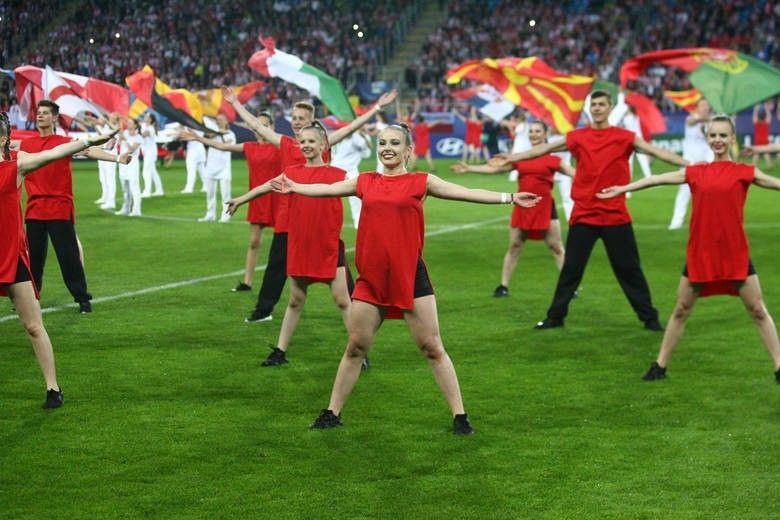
xmin=284 ymin=165 xmax=346 ymax=283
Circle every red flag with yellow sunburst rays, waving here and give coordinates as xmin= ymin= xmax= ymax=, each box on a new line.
xmin=446 ymin=57 xmax=594 ymax=133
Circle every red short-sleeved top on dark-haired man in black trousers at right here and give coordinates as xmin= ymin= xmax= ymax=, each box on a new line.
xmin=566 ymin=126 xmax=636 ymax=226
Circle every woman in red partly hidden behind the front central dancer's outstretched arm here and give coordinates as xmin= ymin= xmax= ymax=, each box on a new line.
xmin=227 ymin=122 xmax=350 ymax=366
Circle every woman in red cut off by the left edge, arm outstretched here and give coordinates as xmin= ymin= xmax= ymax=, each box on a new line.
xmin=0 ymin=116 xmax=116 ymax=408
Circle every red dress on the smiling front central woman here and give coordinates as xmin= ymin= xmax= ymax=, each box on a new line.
xmin=352 ymin=172 xmax=428 ymax=318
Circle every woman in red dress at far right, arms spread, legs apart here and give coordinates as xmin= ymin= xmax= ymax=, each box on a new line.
xmin=597 ymin=115 xmax=780 ymax=383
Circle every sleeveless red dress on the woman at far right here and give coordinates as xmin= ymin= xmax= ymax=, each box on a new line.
xmin=685 ymin=161 xmax=755 ymax=296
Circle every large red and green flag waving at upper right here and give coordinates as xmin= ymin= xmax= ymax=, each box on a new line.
xmin=620 ymin=47 xmax=780 ymax=114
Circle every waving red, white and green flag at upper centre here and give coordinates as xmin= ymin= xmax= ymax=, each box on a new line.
xmin=249 ymin=38 xmax=355 ymax=121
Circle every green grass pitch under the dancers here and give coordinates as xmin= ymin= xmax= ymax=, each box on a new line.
xmin=0 ymin=156 xmax=780 ymax=518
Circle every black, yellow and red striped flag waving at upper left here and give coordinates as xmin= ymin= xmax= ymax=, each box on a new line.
xmin=125 ymin=65 xmax=214 ymax=134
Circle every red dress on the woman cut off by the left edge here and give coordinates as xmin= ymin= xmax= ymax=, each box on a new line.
xmin=0 ymin=160 xmax=38 ymax=298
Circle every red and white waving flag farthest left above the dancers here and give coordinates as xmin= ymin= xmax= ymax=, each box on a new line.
xmin=14 ymin=65 xmax=130 ymax=121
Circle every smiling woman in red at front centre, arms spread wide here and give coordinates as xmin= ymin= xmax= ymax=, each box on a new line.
xmin=272 ymin=125 xmax=538 ymax=434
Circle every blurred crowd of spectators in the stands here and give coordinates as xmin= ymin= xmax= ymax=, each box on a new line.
xmin=0 ymin=0 xmax=780 ymax=117
